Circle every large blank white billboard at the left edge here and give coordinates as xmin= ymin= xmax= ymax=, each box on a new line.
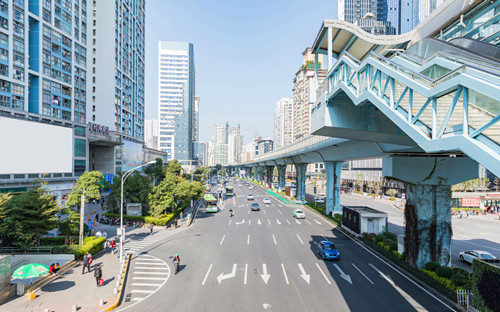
xmin=0 ymin=117 xmax=73 ymax=174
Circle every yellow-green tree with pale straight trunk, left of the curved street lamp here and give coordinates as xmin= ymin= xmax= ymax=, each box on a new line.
xmin=66 ymin=171 xmax=102 ymax=246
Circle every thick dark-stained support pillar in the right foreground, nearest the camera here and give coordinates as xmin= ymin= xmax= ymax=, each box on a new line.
xmin=405 ymin=183 xmax=452 ymax=269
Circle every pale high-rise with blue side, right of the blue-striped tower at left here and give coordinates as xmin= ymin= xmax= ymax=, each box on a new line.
xmin=90 ymin=0 xmax=145 ymax=142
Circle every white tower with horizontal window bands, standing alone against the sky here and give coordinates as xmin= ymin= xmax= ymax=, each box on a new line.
xmin=158 ymin=41 xmax=195 ymax=164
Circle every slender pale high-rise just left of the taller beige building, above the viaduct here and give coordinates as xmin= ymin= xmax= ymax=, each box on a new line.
xmin=274 ymin=98 xmax=293 ymax=149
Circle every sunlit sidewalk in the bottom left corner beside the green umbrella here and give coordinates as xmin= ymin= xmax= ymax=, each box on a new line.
xmin=0 ymin=252 xmax=120 ymax=312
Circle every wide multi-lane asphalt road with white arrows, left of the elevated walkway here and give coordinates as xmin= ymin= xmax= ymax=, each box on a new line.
xmin=115 ymin=185 xmax=452 ymax=312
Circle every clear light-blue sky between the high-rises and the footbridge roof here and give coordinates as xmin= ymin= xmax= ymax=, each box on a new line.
xmin=145 ymin=0 xmax=337 ymax=143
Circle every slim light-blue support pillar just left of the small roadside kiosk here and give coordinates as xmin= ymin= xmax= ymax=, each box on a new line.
xmin=325 ymin=161 xmax=343 ymax=215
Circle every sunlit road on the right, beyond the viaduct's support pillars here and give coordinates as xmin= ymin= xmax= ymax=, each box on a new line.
xmin=307 ymin=188 xmax=500 ymax=271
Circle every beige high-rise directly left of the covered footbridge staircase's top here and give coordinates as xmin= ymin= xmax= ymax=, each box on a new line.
xmin=293 ymin=48 xmax=326 ymax=141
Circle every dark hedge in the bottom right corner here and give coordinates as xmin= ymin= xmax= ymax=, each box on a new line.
xmin=472 ymin=259 xmax=500 ymax=312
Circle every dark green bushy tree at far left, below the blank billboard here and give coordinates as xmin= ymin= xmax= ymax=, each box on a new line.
xmin=2 ymin=183 xmax=58 ymax=249
